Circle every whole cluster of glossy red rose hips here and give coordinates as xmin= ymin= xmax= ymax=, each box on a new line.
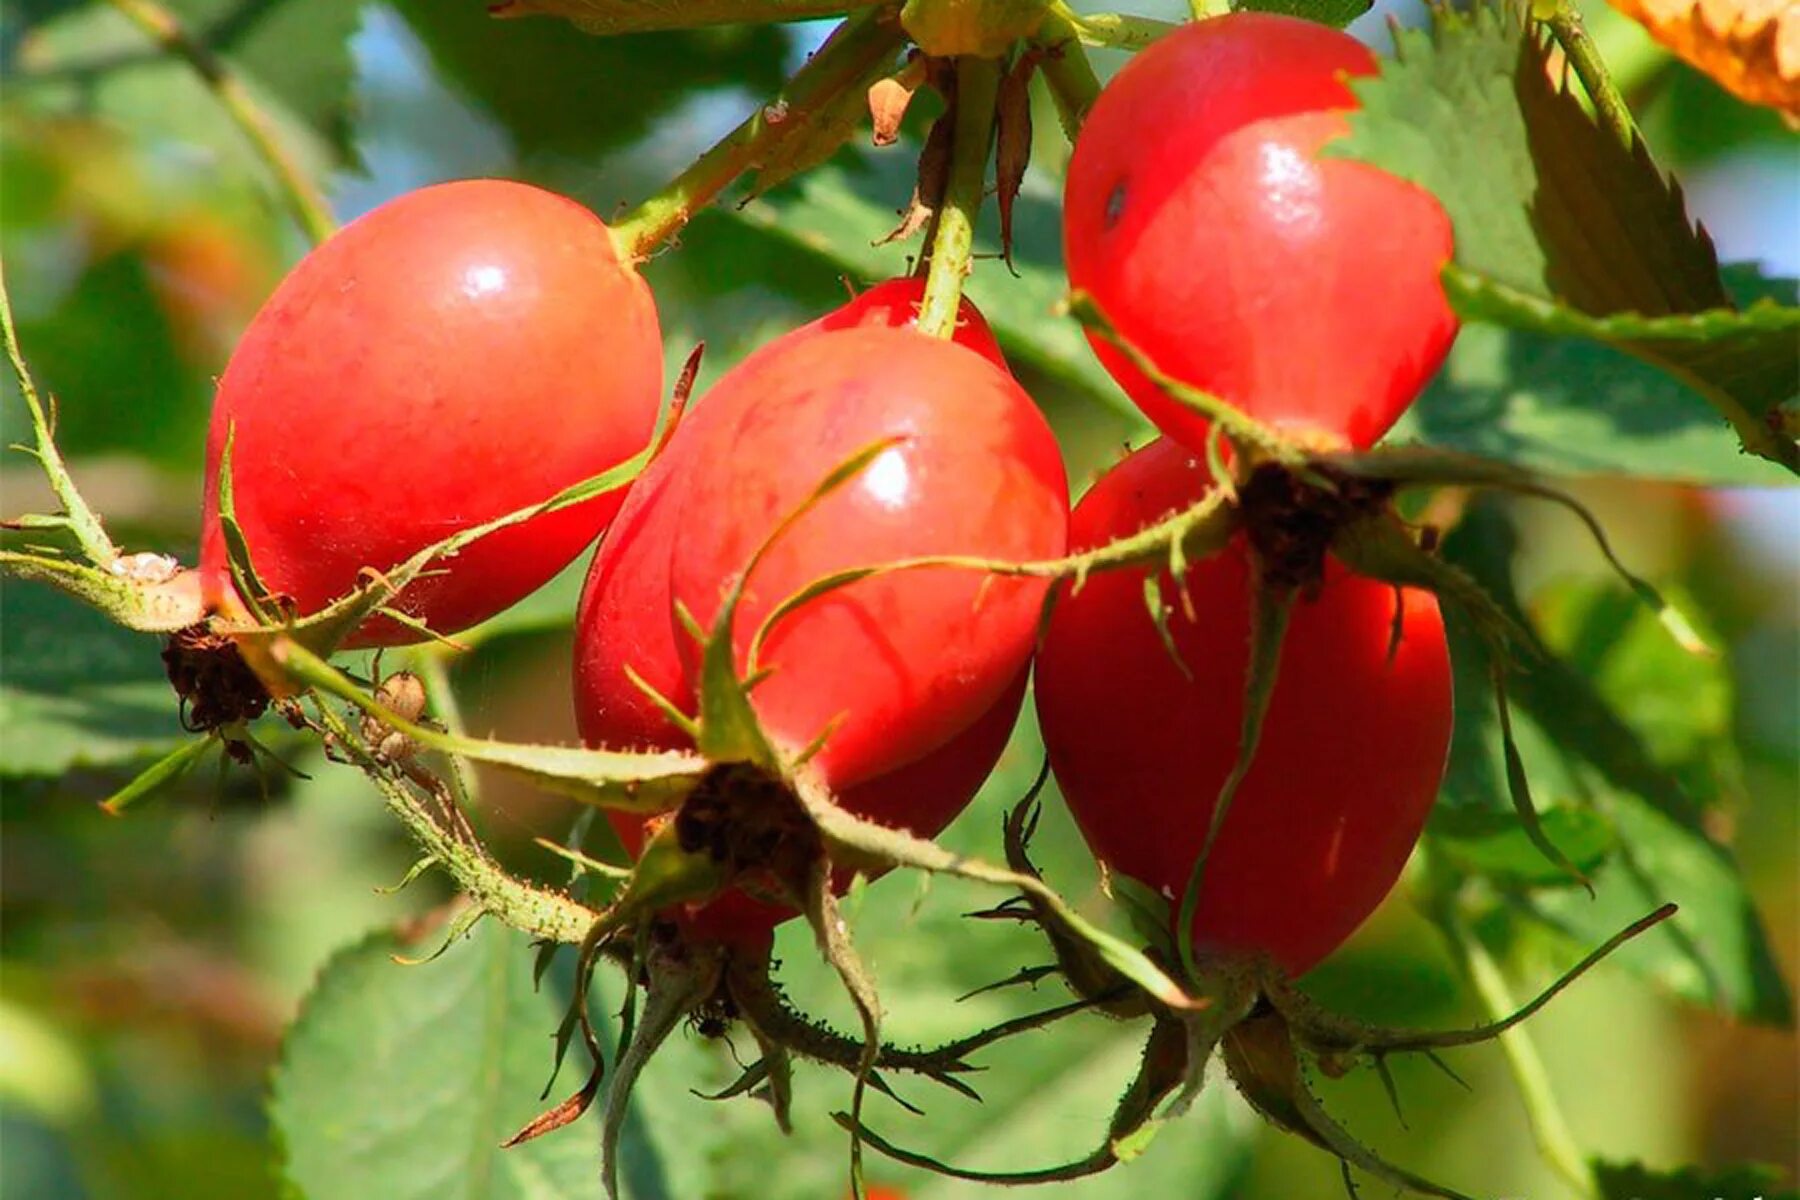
xmin=171 ymin=14 xmax=1605 ymax=1200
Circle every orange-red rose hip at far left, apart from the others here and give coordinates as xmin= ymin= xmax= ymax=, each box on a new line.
xmin=202 ymin=180 xmax=662 ymax=646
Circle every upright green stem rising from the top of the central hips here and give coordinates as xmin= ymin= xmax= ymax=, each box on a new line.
xmin=918 ymin=56 xmax=1001 ymax=338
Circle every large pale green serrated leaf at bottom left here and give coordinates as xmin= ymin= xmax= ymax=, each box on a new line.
xmin=270 ymin=921 xmax=704 ymax=1200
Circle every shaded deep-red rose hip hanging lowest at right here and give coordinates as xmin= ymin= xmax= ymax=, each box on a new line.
xmin=1037 ymin=439 xmax=1451 ymax=975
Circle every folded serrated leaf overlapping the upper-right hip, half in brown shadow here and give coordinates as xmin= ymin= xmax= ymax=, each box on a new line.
xmin=1325 ymin=4 xmax=1800 ymax=470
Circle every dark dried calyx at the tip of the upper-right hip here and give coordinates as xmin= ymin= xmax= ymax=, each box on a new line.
xmin=1238 ymin=462 xmax=1393 ymax=594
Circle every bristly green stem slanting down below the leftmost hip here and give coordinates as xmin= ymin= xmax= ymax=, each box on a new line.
xmin=319 ymin=702 xmax=599 ymax=945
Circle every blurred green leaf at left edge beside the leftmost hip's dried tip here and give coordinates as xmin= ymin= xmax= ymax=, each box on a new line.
xmin=0 ymin=581 xmax=187 ymax=775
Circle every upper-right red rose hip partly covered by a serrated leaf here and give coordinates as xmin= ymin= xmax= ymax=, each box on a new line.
xmin=1062 ymin=13 xmax=1456 ymax=450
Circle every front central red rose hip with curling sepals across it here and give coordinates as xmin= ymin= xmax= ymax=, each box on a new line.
xmin=670 ymin=327 xmax=1067 ymax=788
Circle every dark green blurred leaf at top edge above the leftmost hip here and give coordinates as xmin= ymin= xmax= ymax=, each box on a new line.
xmin=394 ymin=0 xmax=787 ymax=157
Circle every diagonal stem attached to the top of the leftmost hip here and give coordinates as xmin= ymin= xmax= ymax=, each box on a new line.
xmin=612 ymin=11 xmax=902 ymax=263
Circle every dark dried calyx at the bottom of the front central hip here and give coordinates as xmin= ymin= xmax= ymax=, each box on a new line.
xmin=675 ymin=763 xmax=824 ymax=885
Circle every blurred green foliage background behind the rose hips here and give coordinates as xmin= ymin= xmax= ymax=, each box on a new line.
xmin=0 ymin=0 xmax=1800 ymax=1200
